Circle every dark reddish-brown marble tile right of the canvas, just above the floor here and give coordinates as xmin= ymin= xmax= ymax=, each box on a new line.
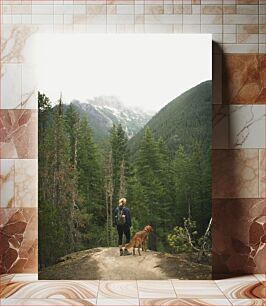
xmin=212 ymin=199 xmax=266 ymax=278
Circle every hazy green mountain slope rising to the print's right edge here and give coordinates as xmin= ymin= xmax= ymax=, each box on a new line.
xmin=129 ymin=81 xmax=212 ymax=156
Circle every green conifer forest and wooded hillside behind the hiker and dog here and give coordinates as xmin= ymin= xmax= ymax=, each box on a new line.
xmin=38 ymin=82 xmax=211 ymax=268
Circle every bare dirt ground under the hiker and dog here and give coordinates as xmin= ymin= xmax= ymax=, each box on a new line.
xmin=39 ymin=248 xmax=211 ymax=280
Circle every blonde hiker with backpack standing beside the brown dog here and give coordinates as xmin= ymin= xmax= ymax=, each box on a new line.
xmin=114 ymin=198 xmax=131 ymax=256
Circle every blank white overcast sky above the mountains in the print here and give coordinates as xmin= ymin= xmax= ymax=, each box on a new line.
xmin=36 ymin=34 xmax=212 ymax=111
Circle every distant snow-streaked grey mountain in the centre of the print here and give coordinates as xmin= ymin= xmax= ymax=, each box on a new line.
xmin=68 ymin=96 xmax=153 ymax=141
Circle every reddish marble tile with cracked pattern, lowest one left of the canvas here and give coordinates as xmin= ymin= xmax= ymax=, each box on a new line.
xmin=0 ymin=208 xmax=38 ymax=273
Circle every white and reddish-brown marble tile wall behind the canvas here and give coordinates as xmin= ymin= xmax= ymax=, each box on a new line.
xmin=0 ymin=0 xmax=266 ymax=280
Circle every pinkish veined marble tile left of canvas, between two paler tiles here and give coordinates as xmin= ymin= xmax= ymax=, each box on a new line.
xmin=0 ymin=109 xmax=38 ymax=159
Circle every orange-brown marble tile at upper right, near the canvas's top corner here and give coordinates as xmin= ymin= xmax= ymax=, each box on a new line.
xmin=223 ymin=54 xmax=266 ymax=104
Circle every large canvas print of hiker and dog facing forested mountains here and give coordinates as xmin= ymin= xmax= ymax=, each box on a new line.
xmin=36 ymin=34 xmax=212 ymax=280
